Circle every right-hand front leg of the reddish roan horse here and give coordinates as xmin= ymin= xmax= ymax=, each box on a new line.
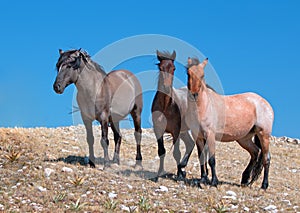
xmin=206 ymin=132 xmax=219 ymax=186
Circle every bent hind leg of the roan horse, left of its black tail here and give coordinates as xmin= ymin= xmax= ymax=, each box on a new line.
xmin=237 ymin=135 xmax=259 ymax=186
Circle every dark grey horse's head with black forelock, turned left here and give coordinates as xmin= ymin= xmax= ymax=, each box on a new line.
xmin=53 ymin=49 xmax=89 ymax=94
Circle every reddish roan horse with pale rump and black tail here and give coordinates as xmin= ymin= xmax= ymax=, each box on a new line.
xmin=186 ymin=58 xmax=274 ymax=189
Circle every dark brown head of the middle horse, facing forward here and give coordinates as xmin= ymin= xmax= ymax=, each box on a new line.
xmin=156 ymin=50 xmax=176 ymax=94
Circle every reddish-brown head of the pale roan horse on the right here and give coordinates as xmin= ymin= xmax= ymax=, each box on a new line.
xmin=187 ymin=58 xmax=208 ymax=100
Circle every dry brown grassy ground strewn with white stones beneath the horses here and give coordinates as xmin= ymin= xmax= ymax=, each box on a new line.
xmin=0 ymin=126 xmax=300 ymax=212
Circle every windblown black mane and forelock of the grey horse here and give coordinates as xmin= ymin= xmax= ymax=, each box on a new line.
xmin=56 ymin=49 xmax=106 ymax=74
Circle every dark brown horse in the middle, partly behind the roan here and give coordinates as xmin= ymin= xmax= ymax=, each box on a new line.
xmin=151 ymin=50 xmax=195 ymax=179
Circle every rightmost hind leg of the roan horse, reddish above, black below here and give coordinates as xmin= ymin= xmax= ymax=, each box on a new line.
xmin=257 ymin=130 xmax=271 ymax=189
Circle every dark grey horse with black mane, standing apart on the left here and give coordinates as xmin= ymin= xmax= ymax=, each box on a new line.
xmin=53 ymin=49 xmax=143 ymax=167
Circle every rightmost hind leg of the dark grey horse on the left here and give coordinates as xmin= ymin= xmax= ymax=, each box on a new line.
xmin=131 ymin=107 xmax=142 ymax=166
